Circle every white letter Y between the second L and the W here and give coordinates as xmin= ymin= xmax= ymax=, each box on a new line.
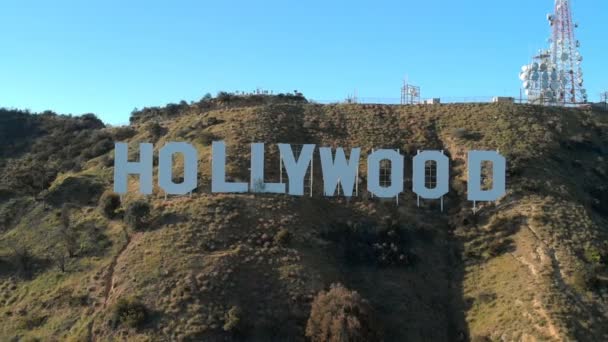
xmin=278 ymin=144 xmax=315 ymax=196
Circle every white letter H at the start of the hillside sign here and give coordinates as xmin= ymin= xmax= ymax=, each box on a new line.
xmin=114 ymin=143 xmax=153 ymax=195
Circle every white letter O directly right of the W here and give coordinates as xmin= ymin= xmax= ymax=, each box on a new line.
xmin=367 ymin=150 xmax=403 ymax=198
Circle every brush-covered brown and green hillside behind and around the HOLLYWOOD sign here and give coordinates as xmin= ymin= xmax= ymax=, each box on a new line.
xmin=0 ymin=94 xmax=608 ymax=341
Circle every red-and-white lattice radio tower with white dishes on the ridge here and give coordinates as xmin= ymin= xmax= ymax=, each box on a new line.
xmin=520 ymin=0 xmax=587 ymax=105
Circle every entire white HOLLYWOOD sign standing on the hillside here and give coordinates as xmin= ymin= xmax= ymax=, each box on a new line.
xmin=114 ymin=141 xmax=506 ymax=201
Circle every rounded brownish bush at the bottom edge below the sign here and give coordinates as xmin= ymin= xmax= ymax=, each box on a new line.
xmin=306 ymin=284 xmax=382 ymax=342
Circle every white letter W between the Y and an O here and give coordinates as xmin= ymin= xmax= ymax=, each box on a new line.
xmin=319 ymin=147 xmax=361 ymax=197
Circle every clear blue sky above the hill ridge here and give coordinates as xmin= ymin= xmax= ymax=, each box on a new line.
xmin=0 ymin=0 xmax=608 ymax=124
